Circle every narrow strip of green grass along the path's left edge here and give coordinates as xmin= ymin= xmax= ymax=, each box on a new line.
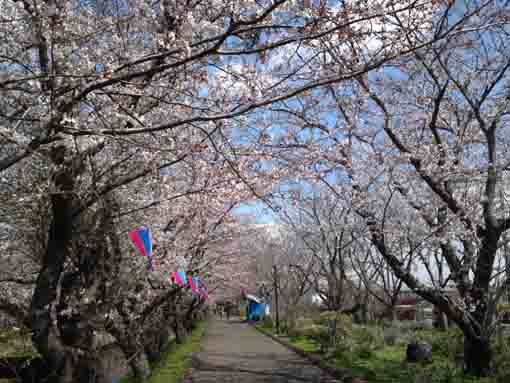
xmin=147 ymin=321 xmax=207 ymax=383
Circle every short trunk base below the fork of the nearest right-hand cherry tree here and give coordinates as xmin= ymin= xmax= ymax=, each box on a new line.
xmin=464 ymin=335 xmax=492 ymax=377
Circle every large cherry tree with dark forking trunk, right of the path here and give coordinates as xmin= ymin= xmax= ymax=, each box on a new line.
xmin=338 ymin=1 xmax=509 ymax=375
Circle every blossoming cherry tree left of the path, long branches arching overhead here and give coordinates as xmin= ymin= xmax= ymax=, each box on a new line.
xmin=0 ymin=0 xmax=496 ymax=382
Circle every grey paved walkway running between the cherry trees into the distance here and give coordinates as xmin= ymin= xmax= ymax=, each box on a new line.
xmin=186 ymin=320 xmax=338 ymax=383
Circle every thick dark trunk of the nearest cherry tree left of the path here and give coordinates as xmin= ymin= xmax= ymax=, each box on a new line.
xmin=30 ymin=144 xmax=104 ymax=383
